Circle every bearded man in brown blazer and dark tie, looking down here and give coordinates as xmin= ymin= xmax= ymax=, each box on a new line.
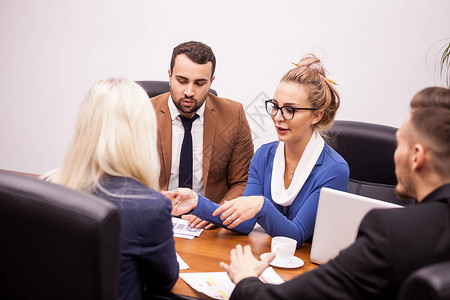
xmin=151 ymin=42 xmax=254 ymax=229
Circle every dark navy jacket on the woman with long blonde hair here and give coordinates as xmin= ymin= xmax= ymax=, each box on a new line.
xmin=95 ymin=175 xmax=180 ymax=299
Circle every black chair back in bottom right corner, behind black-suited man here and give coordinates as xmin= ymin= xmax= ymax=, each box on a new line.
xmin=397 ymin=261 xmax=450 ymax=300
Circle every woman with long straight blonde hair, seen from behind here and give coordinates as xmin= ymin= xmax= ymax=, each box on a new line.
xmin=49 ymin=78 xmax=179 ymax=299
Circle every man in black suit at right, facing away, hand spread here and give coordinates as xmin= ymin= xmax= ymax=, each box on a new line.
xmin=221 ymin=87 xmax=450 ymax=300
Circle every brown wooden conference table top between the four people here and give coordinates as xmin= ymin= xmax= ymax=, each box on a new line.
xmin=171 ymin=228 xmax=317 ymax=299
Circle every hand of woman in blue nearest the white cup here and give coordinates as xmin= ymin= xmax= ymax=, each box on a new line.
xmin=213 ymin=196 xmax=264 ymax=228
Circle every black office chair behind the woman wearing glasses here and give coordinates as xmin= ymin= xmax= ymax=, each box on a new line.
xmin=325 ymin=121 xmax=413 ymax=205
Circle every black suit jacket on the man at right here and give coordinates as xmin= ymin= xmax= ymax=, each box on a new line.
xmin=231 ymin=184 xmax=450 ymax=300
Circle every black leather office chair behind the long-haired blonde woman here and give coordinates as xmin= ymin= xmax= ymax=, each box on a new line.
xmin=0 ymin=171 xmax=121 ymax=299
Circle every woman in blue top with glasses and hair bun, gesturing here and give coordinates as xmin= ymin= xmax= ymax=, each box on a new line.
xmin=167 ymin=55 xmax=349 ymax=246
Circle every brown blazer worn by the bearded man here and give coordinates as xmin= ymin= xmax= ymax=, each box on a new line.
xmin=151 ymin=93 xmax=254 ymax=203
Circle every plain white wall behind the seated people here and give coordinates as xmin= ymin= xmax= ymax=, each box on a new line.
xmin=0 ymin=0 xmax=450 ymax=173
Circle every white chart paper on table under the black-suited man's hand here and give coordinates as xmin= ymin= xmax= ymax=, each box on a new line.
xmin=180 ymin=267 xmax=284 ymax=299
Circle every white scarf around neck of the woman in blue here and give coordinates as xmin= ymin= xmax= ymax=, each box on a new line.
xmin=271 ymin=131 xmax=325 ymax=206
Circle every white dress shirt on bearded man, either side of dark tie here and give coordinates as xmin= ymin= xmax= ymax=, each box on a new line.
xmin=168 ymin=95 xmax=206 ymax=195
